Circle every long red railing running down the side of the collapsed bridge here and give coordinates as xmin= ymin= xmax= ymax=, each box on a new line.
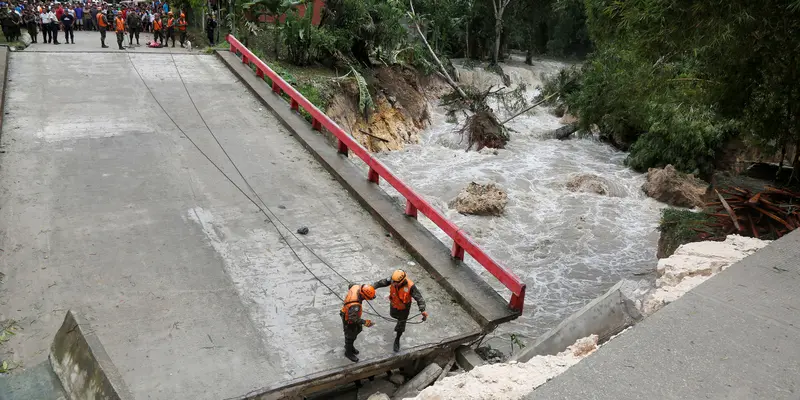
xmin=226 ymin=35 xmax=525 ymax=312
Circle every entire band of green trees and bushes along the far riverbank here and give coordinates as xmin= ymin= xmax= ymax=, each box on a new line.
xmin=212 ymin=0 xmax=800 ymax=179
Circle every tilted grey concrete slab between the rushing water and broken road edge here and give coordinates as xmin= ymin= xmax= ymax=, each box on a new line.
xmin=511 ymin=281 xmax=642 ymax=362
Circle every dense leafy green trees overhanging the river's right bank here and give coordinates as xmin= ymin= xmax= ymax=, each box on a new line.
xmin=554 ymin=0 xmax=800 ymax=178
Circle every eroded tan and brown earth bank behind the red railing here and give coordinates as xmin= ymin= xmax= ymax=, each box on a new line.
xmin=326 ymin=66 xmax=447 ymax=152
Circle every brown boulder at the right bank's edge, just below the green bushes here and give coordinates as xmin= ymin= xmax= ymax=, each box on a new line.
xmin=642 ymin=165 xmax=709 ymax=208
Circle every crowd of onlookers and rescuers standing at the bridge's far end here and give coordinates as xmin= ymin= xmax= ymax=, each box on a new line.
xmin=0 ymin=0 xmax=217 ymax=50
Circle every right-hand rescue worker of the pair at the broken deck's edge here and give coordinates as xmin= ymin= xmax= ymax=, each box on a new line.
xmin=372 ymin=269 xmax=428 ymax=351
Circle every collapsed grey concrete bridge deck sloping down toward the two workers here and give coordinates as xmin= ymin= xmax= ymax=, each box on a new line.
xmin=0 ymin=32 xmax=488 ymax=399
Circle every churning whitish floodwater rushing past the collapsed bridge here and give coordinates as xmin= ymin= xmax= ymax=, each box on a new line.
xmin=368 ymin=62 xmax=663 ymax=344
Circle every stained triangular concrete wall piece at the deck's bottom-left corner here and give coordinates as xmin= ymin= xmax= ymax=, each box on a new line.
xmin=50 ymin=310 xmax=133 ymax=400
